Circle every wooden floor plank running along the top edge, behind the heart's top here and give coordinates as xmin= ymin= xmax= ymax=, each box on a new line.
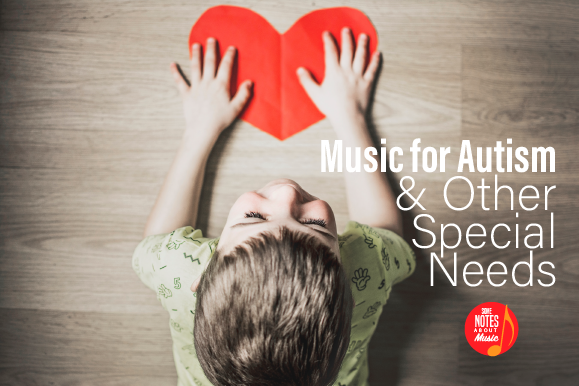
xmin=0 ymin=0 xmax=579 ymax=44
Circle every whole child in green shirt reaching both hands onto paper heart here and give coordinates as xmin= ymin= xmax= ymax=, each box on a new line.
xmin=133 ymin=28 xmax=415 ymax=386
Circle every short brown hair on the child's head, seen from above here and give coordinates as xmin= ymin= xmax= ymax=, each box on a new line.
xmin=194 ymin=227 xmax=353 ymax=386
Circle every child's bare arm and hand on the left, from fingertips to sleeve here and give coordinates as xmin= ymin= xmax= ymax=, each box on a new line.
xmin=144 ymin=38 xmax=251 ymax=237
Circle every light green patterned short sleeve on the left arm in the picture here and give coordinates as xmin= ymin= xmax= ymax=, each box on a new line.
xmin=133 ymin=226 xmax=218 ymax=308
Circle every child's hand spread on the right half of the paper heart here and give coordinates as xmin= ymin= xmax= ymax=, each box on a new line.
xmin=297 ymin=28 xmax=380 ymax=128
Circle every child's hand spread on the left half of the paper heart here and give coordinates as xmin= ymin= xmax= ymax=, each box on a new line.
xmin=171 ymin=38 xmax=252 ymax=141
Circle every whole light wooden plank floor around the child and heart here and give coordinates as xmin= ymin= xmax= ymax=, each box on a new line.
xmin=0 ymin=0 xmax=579 ymax=386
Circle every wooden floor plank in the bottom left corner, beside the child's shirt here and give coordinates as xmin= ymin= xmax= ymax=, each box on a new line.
xmin=0 ymin=309 xmax=177 ymax=386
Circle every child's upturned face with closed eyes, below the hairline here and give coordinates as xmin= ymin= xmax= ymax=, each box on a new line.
xmin=218 ymin=179 xmax=340 ymax=257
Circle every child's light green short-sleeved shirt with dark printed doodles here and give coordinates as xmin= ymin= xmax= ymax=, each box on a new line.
xmin=133 ymin=221 xmax=416 ymax=386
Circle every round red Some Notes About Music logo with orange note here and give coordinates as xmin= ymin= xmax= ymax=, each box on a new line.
xmin=464 ymin=302 xmax=519 ymax=357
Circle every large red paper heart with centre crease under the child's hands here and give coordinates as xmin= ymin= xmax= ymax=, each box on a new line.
xmin=189 ymin=5 xmax=378 ymax=141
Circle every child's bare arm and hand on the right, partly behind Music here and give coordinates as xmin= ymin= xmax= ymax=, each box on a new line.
xmin=298 ymin=28 xmax=402 ymax=235
